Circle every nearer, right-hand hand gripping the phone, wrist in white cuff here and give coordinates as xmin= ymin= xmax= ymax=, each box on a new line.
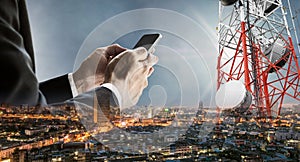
xmin=105 ymin=47 xmax=158 ymax=108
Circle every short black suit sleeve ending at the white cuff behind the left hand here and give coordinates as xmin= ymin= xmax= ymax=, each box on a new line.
xmin=40 ymin=75 xmax=73 ymax=104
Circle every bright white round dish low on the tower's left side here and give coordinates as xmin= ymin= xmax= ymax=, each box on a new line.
xmin=215 ymin=80 xmax=252 ymax=113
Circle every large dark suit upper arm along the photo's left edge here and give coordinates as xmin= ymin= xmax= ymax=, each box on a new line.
xmin=0 ymin=0 xmax=42 ymax=105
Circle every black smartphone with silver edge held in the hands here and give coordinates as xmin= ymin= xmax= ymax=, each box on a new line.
xmin=133 ymin=33 xmax=162 ymax=53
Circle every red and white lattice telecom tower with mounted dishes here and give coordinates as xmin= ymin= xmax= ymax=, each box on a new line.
xmin=216 ymin=0 xmax=300 ymax=117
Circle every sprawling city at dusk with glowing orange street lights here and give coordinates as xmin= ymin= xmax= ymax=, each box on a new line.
xmin=0 ymin=103 xmax=300 ymax=162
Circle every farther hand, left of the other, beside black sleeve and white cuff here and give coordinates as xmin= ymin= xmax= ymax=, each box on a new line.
xmin=73 ymin=44 xmax=126 ymax=94
